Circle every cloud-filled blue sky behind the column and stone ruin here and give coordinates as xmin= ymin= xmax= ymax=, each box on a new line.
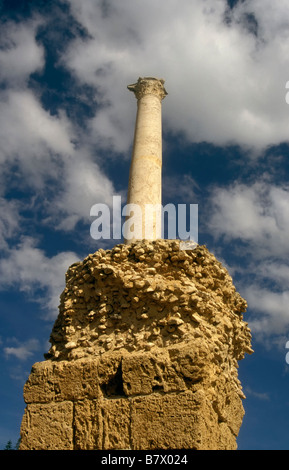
xmin=0 ymin=0 xmax=289 ymax=450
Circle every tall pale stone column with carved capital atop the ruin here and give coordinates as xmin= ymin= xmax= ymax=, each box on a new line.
xmin=124 ymin=77 xmax=167 ymax=243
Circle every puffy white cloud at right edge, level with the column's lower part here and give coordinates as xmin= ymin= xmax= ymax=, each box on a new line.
xmin=209 ymin=181 xmax=289 ymax=258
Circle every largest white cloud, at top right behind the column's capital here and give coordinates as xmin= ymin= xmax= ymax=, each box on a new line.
xmin=63 ymin=0 xmax=289 ymax=151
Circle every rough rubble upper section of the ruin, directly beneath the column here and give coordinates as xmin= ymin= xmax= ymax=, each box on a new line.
xmin=47 ymin=240 xmax=251 ymax=362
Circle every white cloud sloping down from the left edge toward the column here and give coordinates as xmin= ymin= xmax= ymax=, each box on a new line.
xmin=0 ymin=86 xmax=114 ymax=230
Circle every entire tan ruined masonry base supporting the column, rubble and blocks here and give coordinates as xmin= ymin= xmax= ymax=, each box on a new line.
xmin=20 ymin=240 xmax=252 ymax=449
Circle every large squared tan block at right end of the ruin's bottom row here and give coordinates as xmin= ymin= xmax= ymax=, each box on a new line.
xmin=131 ymin=391 xmax=218 ymax=450
